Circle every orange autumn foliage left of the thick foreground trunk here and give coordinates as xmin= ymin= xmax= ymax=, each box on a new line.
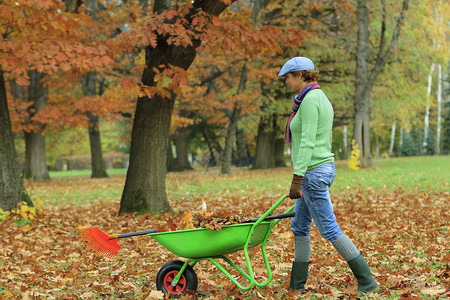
xmin=0 ymin=0 xmax=141 ymax=132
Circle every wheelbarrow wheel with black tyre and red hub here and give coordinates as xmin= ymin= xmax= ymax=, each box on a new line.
xmin=156 ymin=260 xmax=198 ymax=297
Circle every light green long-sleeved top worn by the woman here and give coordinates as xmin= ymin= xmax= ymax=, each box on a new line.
xmin=291 ymin=89 xmax=334 ymax=176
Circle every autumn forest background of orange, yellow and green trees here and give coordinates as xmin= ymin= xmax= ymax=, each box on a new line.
xmin=2 ymin=1 xmax=450 ymax=179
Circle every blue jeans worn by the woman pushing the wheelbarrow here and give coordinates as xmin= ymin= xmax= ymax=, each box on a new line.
xmin=291 ymin=163 xmax=343 ymax=243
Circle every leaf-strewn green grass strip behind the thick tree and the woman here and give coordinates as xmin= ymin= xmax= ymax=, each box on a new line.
xmin=26 ymin=156 xmax=450 ymax=205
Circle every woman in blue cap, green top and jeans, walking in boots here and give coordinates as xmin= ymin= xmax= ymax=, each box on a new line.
xmin=278 ymin=57 xmax=378 ymax=293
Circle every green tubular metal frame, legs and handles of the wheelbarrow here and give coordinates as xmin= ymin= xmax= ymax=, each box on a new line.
xmin=149 ymin=195 xmax=294 ymax=290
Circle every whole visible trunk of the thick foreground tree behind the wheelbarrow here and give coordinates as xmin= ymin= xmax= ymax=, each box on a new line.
xmin=119 ymin=0 xmax=234 ymax=214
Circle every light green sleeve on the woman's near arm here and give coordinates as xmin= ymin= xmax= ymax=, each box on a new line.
xmin=294 ymin=96 xmax=319 ymax=176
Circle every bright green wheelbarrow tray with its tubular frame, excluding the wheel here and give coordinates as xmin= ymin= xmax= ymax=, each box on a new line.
xmin=149 ymin=195 xmax=294 ymax=290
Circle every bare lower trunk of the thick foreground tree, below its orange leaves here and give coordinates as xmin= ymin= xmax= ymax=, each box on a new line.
xmin=119 ymin=93 xmax=174 ymax=214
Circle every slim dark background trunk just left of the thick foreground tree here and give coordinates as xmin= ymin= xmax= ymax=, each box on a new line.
xmin=81 ymin=72 xmax=108 ymax=178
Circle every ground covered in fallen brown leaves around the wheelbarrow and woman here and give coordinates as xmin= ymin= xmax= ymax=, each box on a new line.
xmin=0 ymin=171 xmax=450 ymax=299
